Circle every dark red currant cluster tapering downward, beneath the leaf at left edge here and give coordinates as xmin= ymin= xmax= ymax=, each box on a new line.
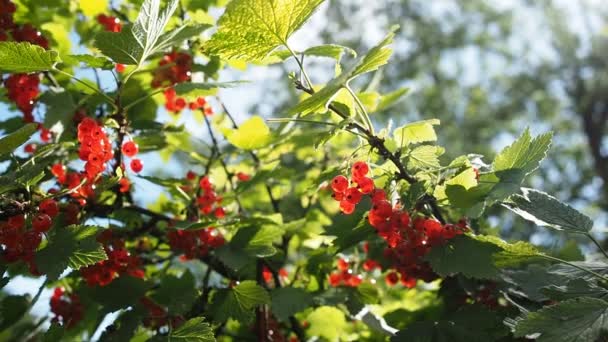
xmin=4 ymin=74 xmax=40 ymax=122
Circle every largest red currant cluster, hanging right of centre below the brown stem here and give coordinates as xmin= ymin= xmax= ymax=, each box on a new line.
xmin=379 ymin=217 xmax=467 ymax=288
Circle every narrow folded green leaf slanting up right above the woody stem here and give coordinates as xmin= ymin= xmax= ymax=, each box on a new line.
xmin=289 ymin=28 xmax=396 ymax=115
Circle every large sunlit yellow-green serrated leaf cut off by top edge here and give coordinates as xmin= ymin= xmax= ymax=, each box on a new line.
xmin=203 ymin=0 xmax=323 ymax=61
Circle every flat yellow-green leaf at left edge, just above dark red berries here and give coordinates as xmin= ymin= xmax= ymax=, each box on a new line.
xmin=0 ymin=42 xmax=60 ymax=73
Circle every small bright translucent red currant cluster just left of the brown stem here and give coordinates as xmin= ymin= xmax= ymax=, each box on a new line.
xmin=331 ymin=161 xmax=375 ymax=214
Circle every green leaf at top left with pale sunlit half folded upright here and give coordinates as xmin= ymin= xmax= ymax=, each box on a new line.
xmin=95 ymin=0 xmax=179 ymax=65
